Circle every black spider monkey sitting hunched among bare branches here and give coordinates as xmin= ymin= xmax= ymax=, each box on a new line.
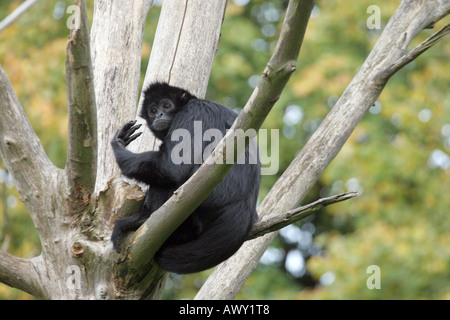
xmin=111 ymin=83 xmax=261 ymax=274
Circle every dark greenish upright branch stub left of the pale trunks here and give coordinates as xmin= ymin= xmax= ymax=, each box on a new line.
xmin=66 ymin=0 xmax=97 ymax=212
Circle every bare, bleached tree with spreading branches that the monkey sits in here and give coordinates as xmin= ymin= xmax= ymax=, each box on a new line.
xmin=0 ymin=0 xmax=450 ymax=299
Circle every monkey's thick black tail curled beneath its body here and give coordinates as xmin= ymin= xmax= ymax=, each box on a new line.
xmin=155 ymin=214 xmax=252 ymax=274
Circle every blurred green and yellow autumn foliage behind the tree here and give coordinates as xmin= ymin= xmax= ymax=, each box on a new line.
xmin=0 ymin=0 xmax=450 ymax=299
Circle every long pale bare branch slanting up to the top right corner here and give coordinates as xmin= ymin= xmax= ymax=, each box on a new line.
xmin=195 ymin=0 xmax=450 ymax=299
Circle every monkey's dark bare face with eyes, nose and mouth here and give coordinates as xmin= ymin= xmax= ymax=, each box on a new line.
xmin=146 ymin=99 xmax=176 ymax=131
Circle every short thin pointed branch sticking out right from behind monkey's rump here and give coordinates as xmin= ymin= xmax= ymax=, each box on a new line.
xmin=247 ymin=192 xmax=358 ymax=240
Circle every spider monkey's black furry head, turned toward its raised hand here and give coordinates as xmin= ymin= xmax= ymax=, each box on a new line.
xmin=139 ymin=82 xmax=197 ymax=140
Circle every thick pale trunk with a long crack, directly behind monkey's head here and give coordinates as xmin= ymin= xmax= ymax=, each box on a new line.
xmin=136 ymin=0 xmax=226 ymax=101
